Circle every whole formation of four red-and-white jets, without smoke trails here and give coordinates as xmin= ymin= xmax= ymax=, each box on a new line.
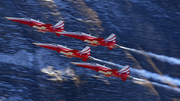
xmin=5 ymin=17 xmax=133 ymax=81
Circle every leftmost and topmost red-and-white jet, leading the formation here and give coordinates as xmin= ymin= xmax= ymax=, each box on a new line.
xmin=5 ymin=17 xmax=64 ymax=35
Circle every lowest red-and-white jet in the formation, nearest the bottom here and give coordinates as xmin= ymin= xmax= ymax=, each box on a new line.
xmin=71 ymin=62 xmax=133 ymax=81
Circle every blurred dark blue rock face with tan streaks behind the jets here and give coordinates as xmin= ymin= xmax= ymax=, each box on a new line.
xmin=0 ymin=0 xmax=180 ymax=101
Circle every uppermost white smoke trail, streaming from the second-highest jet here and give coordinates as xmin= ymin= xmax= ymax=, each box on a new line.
xmin=117 ymin=45 xmax=180 ymax=65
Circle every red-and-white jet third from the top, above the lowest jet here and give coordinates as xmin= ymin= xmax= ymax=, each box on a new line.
xmin=33 ymin=43 xmax=92 ymax=62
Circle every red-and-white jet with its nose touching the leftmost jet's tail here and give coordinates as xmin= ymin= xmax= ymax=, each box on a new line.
xmin=56 ymin=31 xmax=119 ymax=50
